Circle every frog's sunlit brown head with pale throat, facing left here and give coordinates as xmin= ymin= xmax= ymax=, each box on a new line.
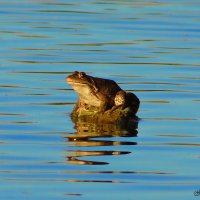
xmin=66 ymin=71 xmax=95 ymax=94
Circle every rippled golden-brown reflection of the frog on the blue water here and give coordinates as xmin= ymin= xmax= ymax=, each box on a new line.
xmin=65 ymin=121 xmax=138 ymax=165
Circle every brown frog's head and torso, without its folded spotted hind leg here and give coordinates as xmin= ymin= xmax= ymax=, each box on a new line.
xmin=66 ymin=71 xmax=122 ymax=113
